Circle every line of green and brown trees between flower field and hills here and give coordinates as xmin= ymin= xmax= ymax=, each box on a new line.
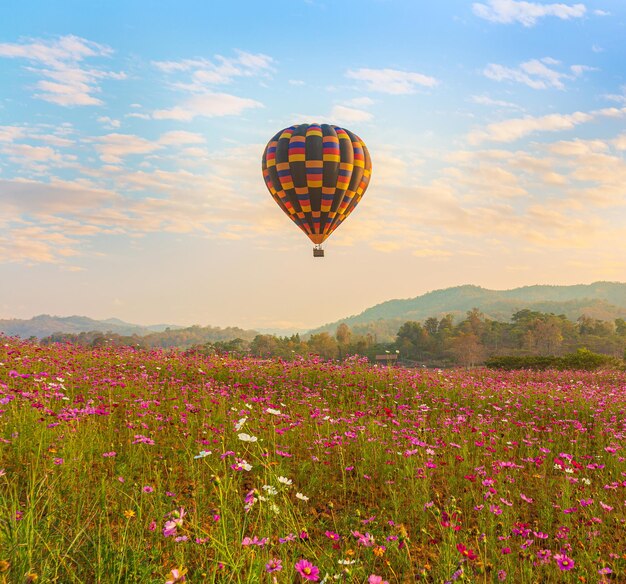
xmin=41 ymin=308 xmax=626 ymax=367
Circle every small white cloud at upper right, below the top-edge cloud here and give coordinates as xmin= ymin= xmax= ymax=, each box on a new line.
xmin=483 ymin=57 xmax=593 ymax=89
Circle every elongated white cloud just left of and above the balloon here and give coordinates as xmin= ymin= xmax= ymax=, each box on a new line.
xmin=152 ymin=93 xmax=263 ymax=122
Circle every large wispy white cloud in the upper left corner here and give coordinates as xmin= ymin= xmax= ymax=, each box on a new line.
xmin=0 ymin=35 xmax=126 ymax=106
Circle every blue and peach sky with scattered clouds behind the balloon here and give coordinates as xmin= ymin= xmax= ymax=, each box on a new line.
xmin=0 ymin=0 xmax=626 ymax=332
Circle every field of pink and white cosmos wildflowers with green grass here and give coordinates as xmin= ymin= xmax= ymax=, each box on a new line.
xmin=0 ymin=337 xmax=626 ymax=584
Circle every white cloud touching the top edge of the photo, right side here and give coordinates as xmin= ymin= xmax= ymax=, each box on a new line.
xmin=472 ymin=0 xmax=587 ymax=26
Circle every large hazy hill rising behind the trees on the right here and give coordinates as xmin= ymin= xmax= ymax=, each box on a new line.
xmin=309 ymin=282 xmax=626 ymax=342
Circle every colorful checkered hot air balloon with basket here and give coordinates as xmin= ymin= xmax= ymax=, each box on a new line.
xmin=263 ymin=124 xmax=372 ymax=257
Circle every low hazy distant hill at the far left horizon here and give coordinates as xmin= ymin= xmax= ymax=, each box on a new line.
xmin=0 ymin=314 xmax=182 ymax=339
